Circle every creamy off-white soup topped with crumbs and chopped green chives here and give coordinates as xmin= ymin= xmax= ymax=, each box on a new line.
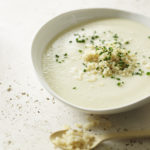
xmin=42 ymin=18 xmax=150 ymax=109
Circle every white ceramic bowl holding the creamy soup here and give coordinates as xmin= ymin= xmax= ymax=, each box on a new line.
xmin=32 ymin=8 xmax=150 ymax=114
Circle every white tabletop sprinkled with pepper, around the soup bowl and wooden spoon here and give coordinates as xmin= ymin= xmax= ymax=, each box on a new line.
xmin=0 ymin=0 xmax=150 ymax=150
